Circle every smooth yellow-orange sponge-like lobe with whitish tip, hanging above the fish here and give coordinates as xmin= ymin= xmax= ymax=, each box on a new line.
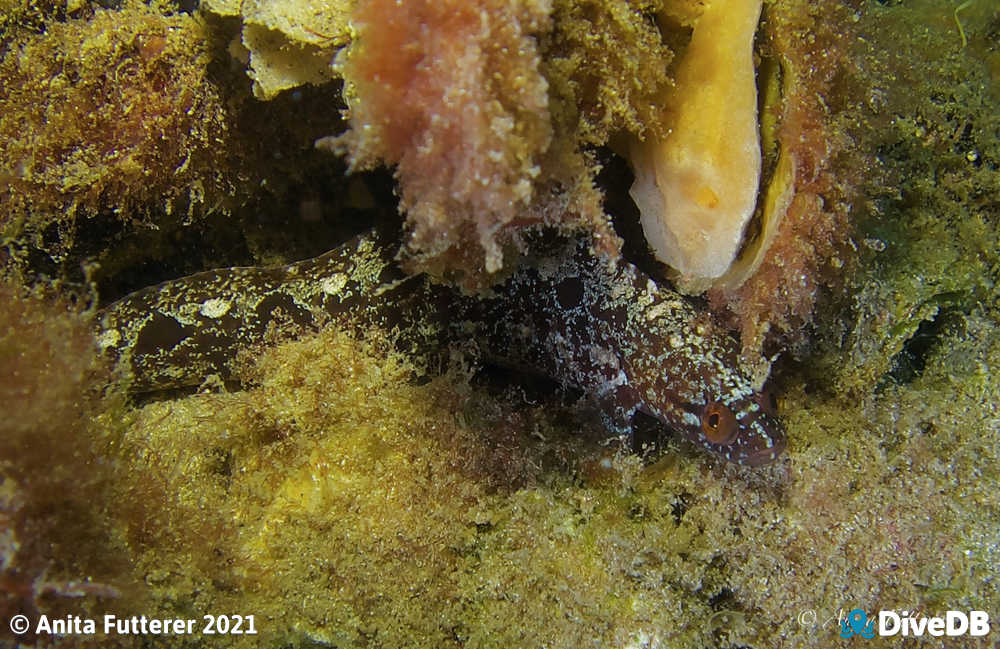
xmin=630 ymin=0 xmax=761 ymax=291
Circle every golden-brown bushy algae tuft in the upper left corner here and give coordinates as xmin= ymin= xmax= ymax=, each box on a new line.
xmin=0 ymin=3 xmax=228 ymax=256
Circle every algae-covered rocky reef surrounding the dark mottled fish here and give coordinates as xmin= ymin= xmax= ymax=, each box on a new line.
xmin=0 ymin=0 xmax=1000 ymax=647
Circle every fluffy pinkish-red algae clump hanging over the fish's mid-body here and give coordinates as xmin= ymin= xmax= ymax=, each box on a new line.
xmin=334 ymin=0 xmax=552 ymax=272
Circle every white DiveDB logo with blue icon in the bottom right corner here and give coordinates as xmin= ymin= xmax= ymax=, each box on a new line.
xmin=840 ymin=608 xmax=990 ymax=638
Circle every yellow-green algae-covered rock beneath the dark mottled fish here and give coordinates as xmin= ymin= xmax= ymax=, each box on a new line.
xmin=76 ymin=318 xmax=1000 ymax=647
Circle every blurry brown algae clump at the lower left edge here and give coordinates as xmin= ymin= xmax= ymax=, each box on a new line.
xmin=0 ymin=280 xmax=144 ymax=646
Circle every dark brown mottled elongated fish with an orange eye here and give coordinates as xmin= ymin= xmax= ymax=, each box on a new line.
xmin=98 ymin=228 xmax=785 ymax=466
